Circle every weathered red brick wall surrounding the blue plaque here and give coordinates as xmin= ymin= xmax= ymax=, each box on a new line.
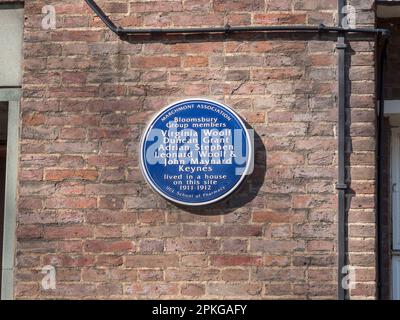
xmin=7 ymin=0 xmax=375 ymax=299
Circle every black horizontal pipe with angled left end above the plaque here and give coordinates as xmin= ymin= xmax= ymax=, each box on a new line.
xmin=85 ymin=0 xmax=390 ymax=36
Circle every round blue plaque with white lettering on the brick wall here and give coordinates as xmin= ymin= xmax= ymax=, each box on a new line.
xmin=140 ymin=98 xmax=253 ymax=206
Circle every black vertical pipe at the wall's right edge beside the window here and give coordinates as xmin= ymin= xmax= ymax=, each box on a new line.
xmin=376 ymin=38 xmax=388 ymax=299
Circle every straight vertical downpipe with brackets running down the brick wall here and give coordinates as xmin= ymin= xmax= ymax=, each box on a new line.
xmin=336 ymin=0 xmax=347 ymax=300
